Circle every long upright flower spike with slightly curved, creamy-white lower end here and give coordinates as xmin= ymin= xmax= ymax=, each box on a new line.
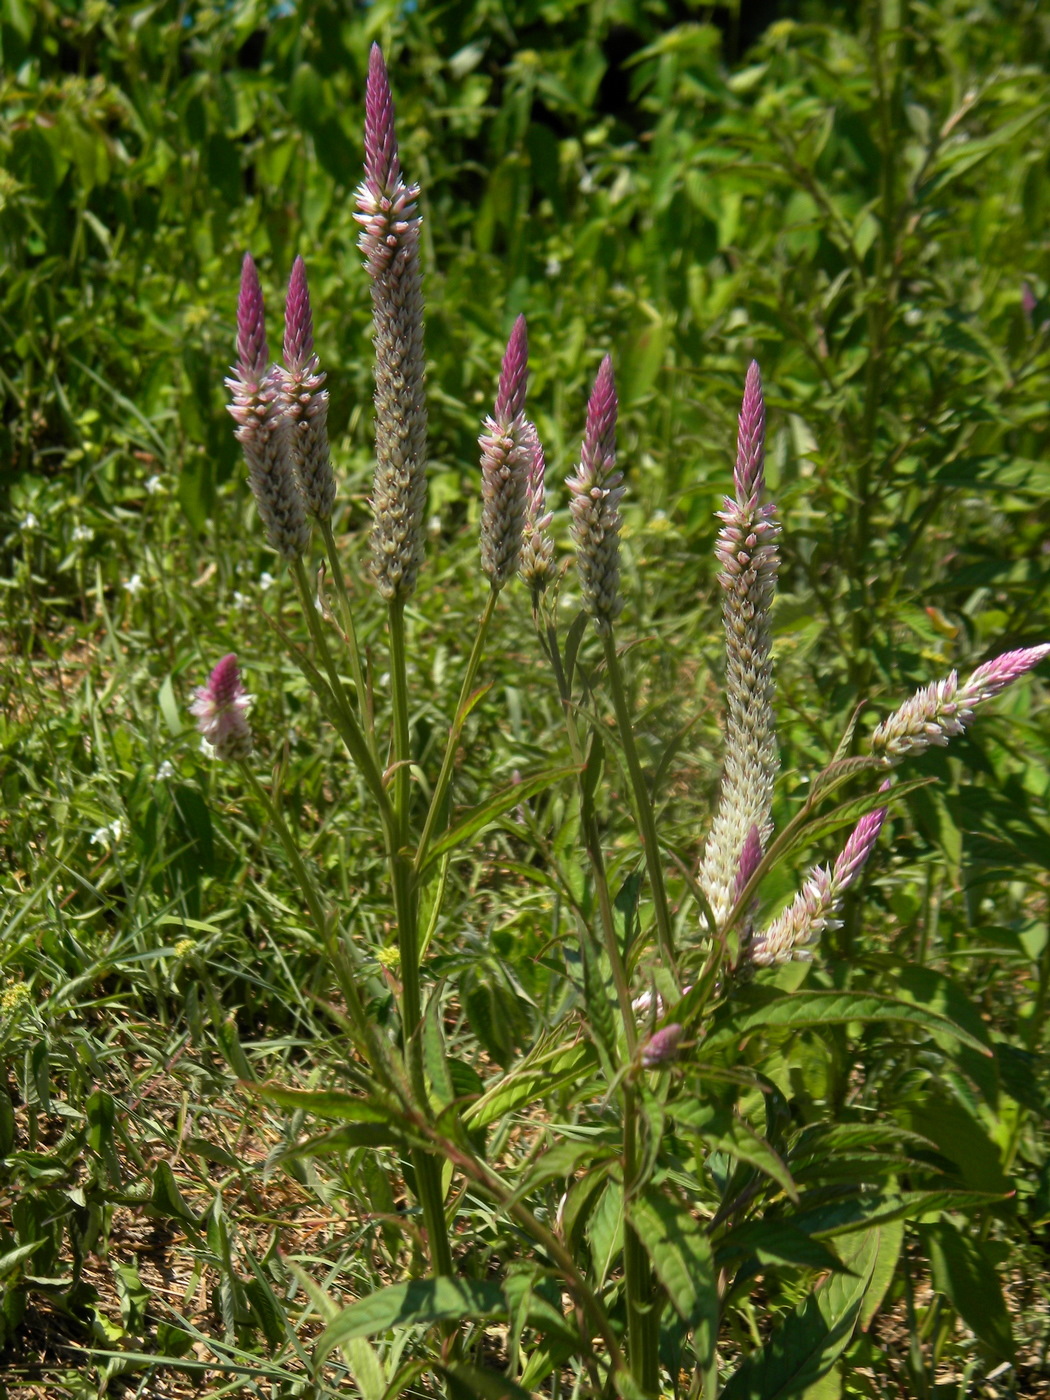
xmin=700 ymin=360 xmax=780 ymax=925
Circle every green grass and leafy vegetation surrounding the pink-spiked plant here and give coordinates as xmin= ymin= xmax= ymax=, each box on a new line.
xmin=0 ymin=0 xmax=1050 ymax=1400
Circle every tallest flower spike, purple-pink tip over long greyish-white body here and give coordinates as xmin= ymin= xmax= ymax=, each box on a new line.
xmin=354 ymin=43 xmax=427 ymax=601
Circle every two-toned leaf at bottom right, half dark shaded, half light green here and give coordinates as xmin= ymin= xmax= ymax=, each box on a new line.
xmin=722 ymin=1226 xmax=881 ymax=1400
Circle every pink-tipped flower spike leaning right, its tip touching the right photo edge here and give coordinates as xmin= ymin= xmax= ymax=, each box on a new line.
xmin=871 ymin=643 xmax=1050 ymax=767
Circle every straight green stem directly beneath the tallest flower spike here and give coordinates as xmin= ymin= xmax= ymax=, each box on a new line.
xmin=386 ymin=598 xmax=452 ymax=1274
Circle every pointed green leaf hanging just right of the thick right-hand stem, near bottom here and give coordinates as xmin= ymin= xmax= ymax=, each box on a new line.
xmin=627 ymin=1186 xmax=718 ymax=1365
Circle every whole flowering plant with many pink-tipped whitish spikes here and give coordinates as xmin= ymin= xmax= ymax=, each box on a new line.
xmin=192 ymin=48 xmax=1050 ymax=1400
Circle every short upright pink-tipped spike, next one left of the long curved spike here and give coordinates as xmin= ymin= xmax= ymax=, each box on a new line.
xmin=566 ymin=356 xmax=624 ymax=631
